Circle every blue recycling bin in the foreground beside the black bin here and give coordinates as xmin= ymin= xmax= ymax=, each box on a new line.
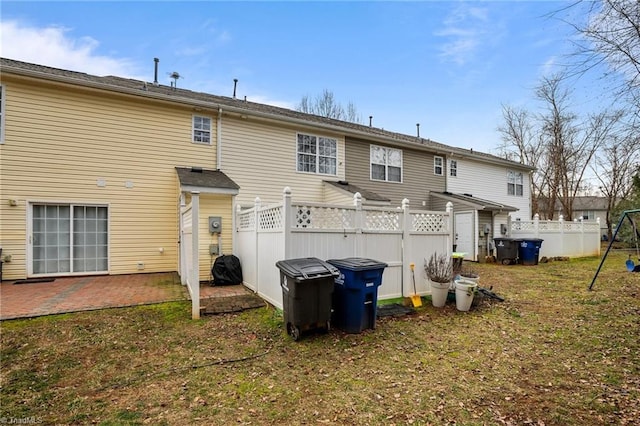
xmin=327 ymin=257 xmax=387 ymax=333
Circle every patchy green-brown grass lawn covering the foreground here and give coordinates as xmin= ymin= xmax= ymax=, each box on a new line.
xmin=0 ymin=253 xmax=640 ymax=426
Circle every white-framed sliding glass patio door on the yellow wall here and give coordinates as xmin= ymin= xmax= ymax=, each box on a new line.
xmin=30 ymin=203 xmax=109 ymax=275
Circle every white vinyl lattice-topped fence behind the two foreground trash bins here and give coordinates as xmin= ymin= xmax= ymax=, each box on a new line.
xmin=234 ymin=188 xmax=453 ymax=308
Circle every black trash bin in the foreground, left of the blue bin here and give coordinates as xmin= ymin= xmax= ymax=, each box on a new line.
xmin=276 ymin=257 xmax=340 ymax=340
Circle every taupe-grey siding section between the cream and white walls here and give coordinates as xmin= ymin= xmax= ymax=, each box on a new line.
xmin=345 ymin=138 xmax=445 ymax=209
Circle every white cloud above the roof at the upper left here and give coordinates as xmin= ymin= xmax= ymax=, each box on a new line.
xmin=0 ymin=21 xmax=145 ymax=80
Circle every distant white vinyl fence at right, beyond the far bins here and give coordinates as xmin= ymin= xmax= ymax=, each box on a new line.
xmin=509 ymin=214 xmax=600 ymax=258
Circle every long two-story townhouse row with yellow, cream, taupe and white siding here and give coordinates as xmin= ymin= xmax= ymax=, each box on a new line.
xmin=0 ymin=59 xmax=530 ymax=280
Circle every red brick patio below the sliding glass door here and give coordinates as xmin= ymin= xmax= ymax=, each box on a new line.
xmin=0 ymin=272 xmax=265 ymax=320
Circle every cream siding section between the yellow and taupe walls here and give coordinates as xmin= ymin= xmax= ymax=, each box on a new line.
xmin=221 ymin=113 xmax=344 ymax=207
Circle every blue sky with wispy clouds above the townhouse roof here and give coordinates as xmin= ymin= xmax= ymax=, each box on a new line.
xmin=0 ymin=0 xmax=590 ymax=153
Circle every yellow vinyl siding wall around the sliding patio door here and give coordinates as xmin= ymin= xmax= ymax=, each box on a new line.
xmin=0 ymin=75 xmax=221 ymax=279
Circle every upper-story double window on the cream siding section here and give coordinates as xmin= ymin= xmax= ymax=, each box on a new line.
xmin=296 ymin=133 xmax=338 ymax=175
